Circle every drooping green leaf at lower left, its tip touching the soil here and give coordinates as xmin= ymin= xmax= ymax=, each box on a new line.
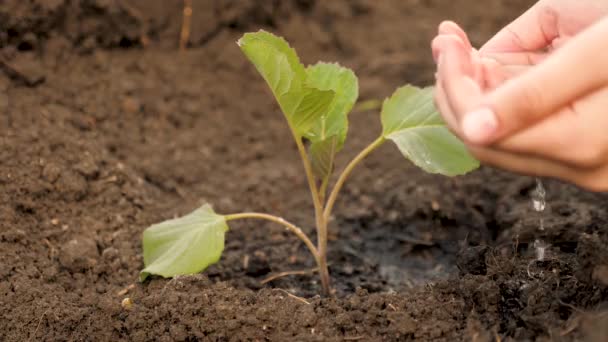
xmin=140 ymin=205 xmax=228 ymax=281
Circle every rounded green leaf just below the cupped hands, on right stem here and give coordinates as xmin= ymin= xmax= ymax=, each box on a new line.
xmin=381 ymin=85 xmax=479 ymax=176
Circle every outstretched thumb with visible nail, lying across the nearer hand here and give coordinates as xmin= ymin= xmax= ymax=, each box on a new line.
xmin=462 ymin=18 xmax=608 ymax=145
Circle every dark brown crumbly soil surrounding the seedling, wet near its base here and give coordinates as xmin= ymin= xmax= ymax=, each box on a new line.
xmin=0 ymin=0 xmax=608 ymax=341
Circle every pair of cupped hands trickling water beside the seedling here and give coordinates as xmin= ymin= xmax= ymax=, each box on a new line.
xmin=432 ymin=0 xmax=608 ymax=191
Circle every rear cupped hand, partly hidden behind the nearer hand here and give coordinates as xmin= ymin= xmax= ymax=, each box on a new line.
xmin=432 ymin=0 xmax=608 ymax=89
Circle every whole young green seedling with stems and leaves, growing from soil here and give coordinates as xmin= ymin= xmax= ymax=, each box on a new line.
xmin=140 ymin=31 xmax=478 ymax=294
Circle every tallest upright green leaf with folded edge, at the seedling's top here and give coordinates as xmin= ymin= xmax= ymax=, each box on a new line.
xmin=238 ymin=31 xmax=335 ymax=136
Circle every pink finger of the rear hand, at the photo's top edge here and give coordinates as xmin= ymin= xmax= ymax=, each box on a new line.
xmin=481 ymin=1 xmax=559 ymax=53
